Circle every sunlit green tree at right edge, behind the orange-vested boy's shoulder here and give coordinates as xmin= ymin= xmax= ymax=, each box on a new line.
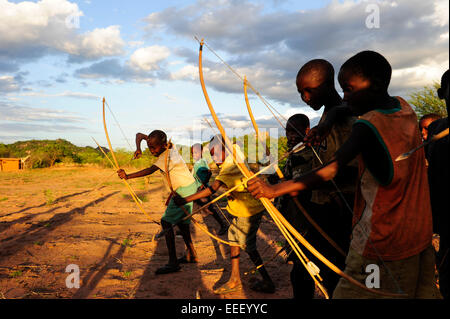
xmin=408 ymin=82 xmax=447 ymax=118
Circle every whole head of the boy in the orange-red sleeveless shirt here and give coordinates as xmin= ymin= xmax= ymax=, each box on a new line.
xmin=338 ymin=51 xmax=392 ymax=115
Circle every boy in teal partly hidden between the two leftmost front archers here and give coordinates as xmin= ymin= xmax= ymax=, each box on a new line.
xmin=191 ymin=143 xmax=228 ymax=235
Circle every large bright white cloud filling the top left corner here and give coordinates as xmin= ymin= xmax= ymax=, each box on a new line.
xmin=0 ymin=0 xmax=125 ymax=63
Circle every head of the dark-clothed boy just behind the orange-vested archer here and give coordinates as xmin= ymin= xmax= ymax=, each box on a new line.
xmin=296 ymin=59 xmax=335 ymax=111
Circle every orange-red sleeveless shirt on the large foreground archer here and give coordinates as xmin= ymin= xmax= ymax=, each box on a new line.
xmin=351 ymin=98 xmax=432 ymax=260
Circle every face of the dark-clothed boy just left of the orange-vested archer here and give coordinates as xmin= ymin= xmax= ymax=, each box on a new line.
xmin=296 ymin=71 xmax=327 ymax=111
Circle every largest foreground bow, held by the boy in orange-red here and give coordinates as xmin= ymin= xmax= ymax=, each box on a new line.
xmin=198 ymin=39 xmax=405 ymax=297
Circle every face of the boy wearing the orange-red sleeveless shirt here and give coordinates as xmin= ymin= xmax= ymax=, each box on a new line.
xmin=338 ymin=69 xmax=370 ymax=115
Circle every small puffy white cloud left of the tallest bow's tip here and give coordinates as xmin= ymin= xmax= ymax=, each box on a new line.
xmin=129 ymin=45 xmax=170 ymax=71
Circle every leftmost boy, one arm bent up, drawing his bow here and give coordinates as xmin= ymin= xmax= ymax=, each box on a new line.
xmin=117 ymin=130 xmax=197 ymax=275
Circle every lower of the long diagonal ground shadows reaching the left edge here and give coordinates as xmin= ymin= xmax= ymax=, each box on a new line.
xmin=0 ymin=191 xmax=119 ymax=262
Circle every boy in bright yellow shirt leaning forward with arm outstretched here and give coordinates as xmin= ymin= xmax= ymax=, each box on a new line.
xmin=175 ymin=135 xmax=275 ymax=294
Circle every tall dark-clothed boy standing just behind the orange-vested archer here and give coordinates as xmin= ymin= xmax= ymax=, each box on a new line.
xmin=294 ymin=59 xmax=358 ymax=299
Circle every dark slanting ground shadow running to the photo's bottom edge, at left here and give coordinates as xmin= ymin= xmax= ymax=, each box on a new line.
xmin=72 ymin=235 xmax=126 ymax=299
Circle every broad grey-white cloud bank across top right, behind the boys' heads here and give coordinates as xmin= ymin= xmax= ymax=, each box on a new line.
xmin=145 ymin=0 xmax=449 ymax=105
